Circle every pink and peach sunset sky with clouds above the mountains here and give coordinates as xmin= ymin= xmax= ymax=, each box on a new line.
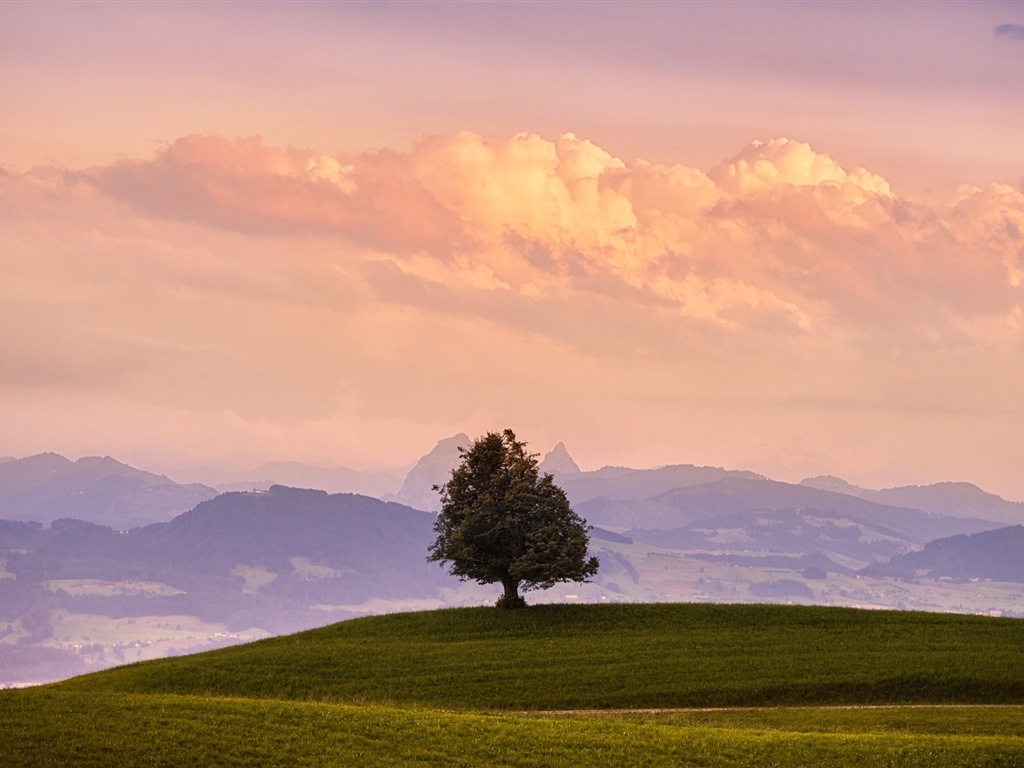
xmin=0 ymin=0 xmax=1024 ymax=501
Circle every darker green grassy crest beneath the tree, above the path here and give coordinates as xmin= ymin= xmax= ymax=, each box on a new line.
xmin=62 ymin=604 xmax=1024 ymax=711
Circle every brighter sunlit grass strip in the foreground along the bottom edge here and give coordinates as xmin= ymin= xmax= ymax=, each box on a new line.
xmin=0 ymin=688 xmax=1024 ymax=768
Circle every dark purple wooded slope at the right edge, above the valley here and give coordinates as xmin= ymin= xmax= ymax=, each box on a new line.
xmin=864 ymin=525 xmax=1024 ymax=584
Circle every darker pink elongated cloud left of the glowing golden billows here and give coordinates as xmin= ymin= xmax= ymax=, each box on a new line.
xmin=92 ymin=136 xmax=458 ymax=248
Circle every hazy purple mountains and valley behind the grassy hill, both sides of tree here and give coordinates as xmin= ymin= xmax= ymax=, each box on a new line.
xmin=0 ymin=435 xmax=1024 ymax=684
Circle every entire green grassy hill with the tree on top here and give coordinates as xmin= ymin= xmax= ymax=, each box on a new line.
xmin=0 ymin=604 xmax=1024 ymax=766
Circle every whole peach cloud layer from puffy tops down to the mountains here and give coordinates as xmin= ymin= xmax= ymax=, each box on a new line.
xmin=0 ymin=132 xmax=1024 ymax=493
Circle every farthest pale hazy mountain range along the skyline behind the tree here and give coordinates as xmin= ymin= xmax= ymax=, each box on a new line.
xmin=9 ymin=434 xmax=1024 ymax=543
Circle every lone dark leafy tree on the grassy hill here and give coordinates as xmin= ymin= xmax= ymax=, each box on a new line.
xmin=427 ymin=429 xmax=598 ymax=608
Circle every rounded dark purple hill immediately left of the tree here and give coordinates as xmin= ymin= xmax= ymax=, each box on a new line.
xmin=131 ymin=485 xmax=438 ymax=602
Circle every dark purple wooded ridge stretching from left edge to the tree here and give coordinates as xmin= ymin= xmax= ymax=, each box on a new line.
xmin=0 ymin=486 xmax=441 ymax=603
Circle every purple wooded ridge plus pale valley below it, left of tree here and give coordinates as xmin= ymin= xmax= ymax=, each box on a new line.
xmin=0 ymin=486 xmax=455 ymax=683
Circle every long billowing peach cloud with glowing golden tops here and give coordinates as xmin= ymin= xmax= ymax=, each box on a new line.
xmin=72 ymin=132 xmax=1024 ymax=354
